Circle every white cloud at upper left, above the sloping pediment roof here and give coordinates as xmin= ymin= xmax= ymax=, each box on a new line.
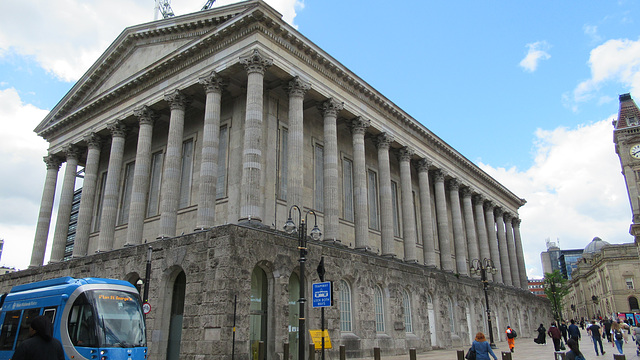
xmin=0 ymin=0 xmax=304 ymax=82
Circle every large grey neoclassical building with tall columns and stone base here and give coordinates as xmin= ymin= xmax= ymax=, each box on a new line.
xmin=0 ymin=0 xmax=551 ymax=359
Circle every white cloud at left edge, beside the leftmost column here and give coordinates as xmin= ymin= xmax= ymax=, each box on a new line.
xmin=0 ymin=88 xmax=55 ymax=269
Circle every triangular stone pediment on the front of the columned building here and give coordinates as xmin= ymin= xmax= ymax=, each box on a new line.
xmin=34 ymin=0 xmax=270 ymax=138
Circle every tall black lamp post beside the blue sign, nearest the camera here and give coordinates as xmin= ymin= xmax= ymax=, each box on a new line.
xmin=284 ymin=205 xmax=322 ymax=360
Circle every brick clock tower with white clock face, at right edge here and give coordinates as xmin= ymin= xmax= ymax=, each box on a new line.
xmin=613 ymin=94 xmax=640 ymax=245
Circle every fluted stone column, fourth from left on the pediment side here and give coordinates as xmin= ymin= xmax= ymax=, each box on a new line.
xmin=96 ymin=120 xmax=126 ymax=252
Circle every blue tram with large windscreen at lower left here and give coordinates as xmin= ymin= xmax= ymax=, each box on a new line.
xmin=0 ymin=276 xmax=147 ymax=360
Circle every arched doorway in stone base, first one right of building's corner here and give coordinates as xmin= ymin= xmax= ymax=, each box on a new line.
xmin=249 ymin=266 xmax=269 ymax=360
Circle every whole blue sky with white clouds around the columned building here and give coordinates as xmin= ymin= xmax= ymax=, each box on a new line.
xmin=0 ymin=0 xmax=640 ymax=277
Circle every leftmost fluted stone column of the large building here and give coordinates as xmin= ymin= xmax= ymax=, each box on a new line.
xmin=29 ymin=155 xmax=61 ymax=268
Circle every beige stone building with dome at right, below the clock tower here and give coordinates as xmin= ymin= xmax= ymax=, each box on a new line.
xmin=563 ymin=238 xmax=640 ymax=319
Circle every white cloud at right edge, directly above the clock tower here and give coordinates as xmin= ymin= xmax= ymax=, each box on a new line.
xmin=572 ymin=39 xmax=640 ymax=103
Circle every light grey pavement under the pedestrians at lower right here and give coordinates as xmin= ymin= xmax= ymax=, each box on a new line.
xmin=348 ymin=330 xmax=640 ymax=360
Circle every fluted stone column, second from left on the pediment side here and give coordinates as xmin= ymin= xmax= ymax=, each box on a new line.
xmin=51 ymin=144 xmax=80 ymax=262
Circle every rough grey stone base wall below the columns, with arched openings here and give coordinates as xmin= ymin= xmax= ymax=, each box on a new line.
xmin=0 ymin=225 xmax=551 ymax=360
